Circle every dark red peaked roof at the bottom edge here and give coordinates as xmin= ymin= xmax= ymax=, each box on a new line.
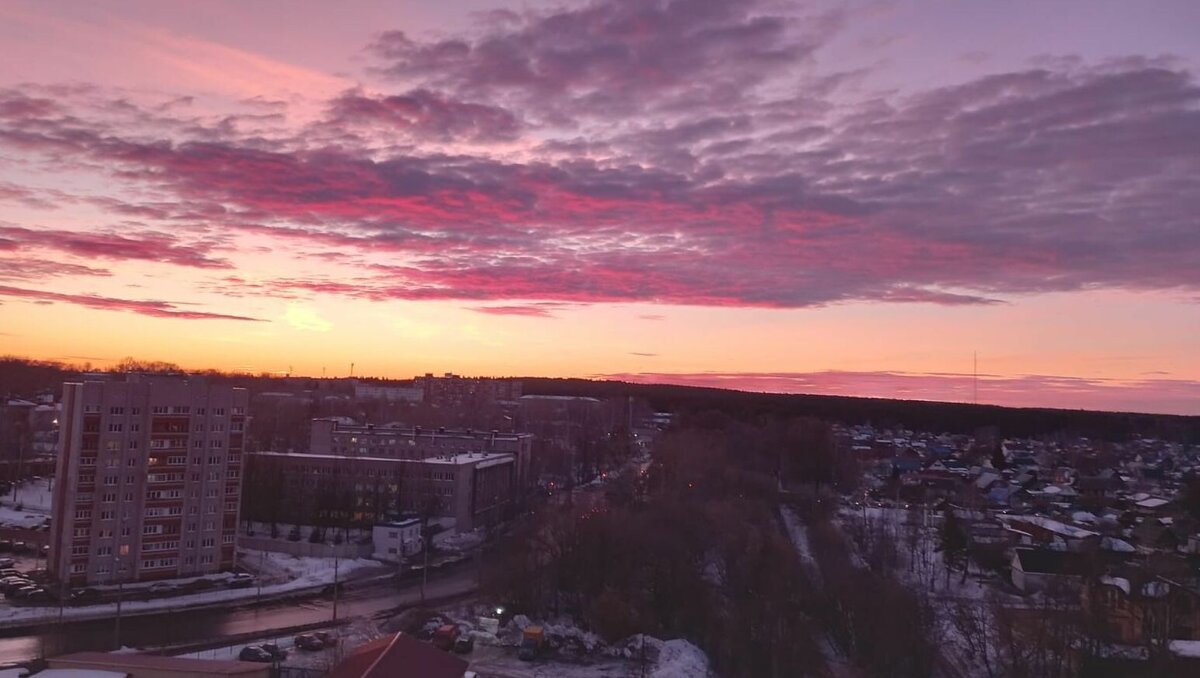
xmin=329 ymin=634 xmax=467 ymax=678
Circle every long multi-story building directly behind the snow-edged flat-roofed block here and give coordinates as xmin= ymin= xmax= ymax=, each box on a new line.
xmin=308 ymin=419 xmax=533 ymax=486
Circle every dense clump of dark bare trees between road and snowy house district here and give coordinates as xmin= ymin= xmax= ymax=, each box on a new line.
xmin=484 ymin=421 xmax=854 ymax=677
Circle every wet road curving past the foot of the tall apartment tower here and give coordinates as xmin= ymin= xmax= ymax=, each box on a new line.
xmin=0 ymin=563 xmax=476 ymax=664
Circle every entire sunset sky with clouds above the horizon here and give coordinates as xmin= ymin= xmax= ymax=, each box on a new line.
xmin=0 ymin=0 xmax=1200 ymax=414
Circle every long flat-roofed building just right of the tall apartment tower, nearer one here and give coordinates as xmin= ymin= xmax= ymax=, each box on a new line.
xmin=246 ymin=452 xmax=517 ymax=532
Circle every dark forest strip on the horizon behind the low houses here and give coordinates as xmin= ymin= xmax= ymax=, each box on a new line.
xmin=522 ymin=378 xmax=1200 ymax=443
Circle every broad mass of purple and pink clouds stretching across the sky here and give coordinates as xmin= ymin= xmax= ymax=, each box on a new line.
xmin=0 ymin=0 xmax=1200 ymax=316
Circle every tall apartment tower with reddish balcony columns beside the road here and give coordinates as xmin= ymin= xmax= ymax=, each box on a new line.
xmin=48 ymin=374 xmax=247 ymax=586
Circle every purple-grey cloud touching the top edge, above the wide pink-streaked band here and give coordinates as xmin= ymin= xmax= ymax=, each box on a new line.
xmin=371 ymin=0 xmax=840 ymax=121
